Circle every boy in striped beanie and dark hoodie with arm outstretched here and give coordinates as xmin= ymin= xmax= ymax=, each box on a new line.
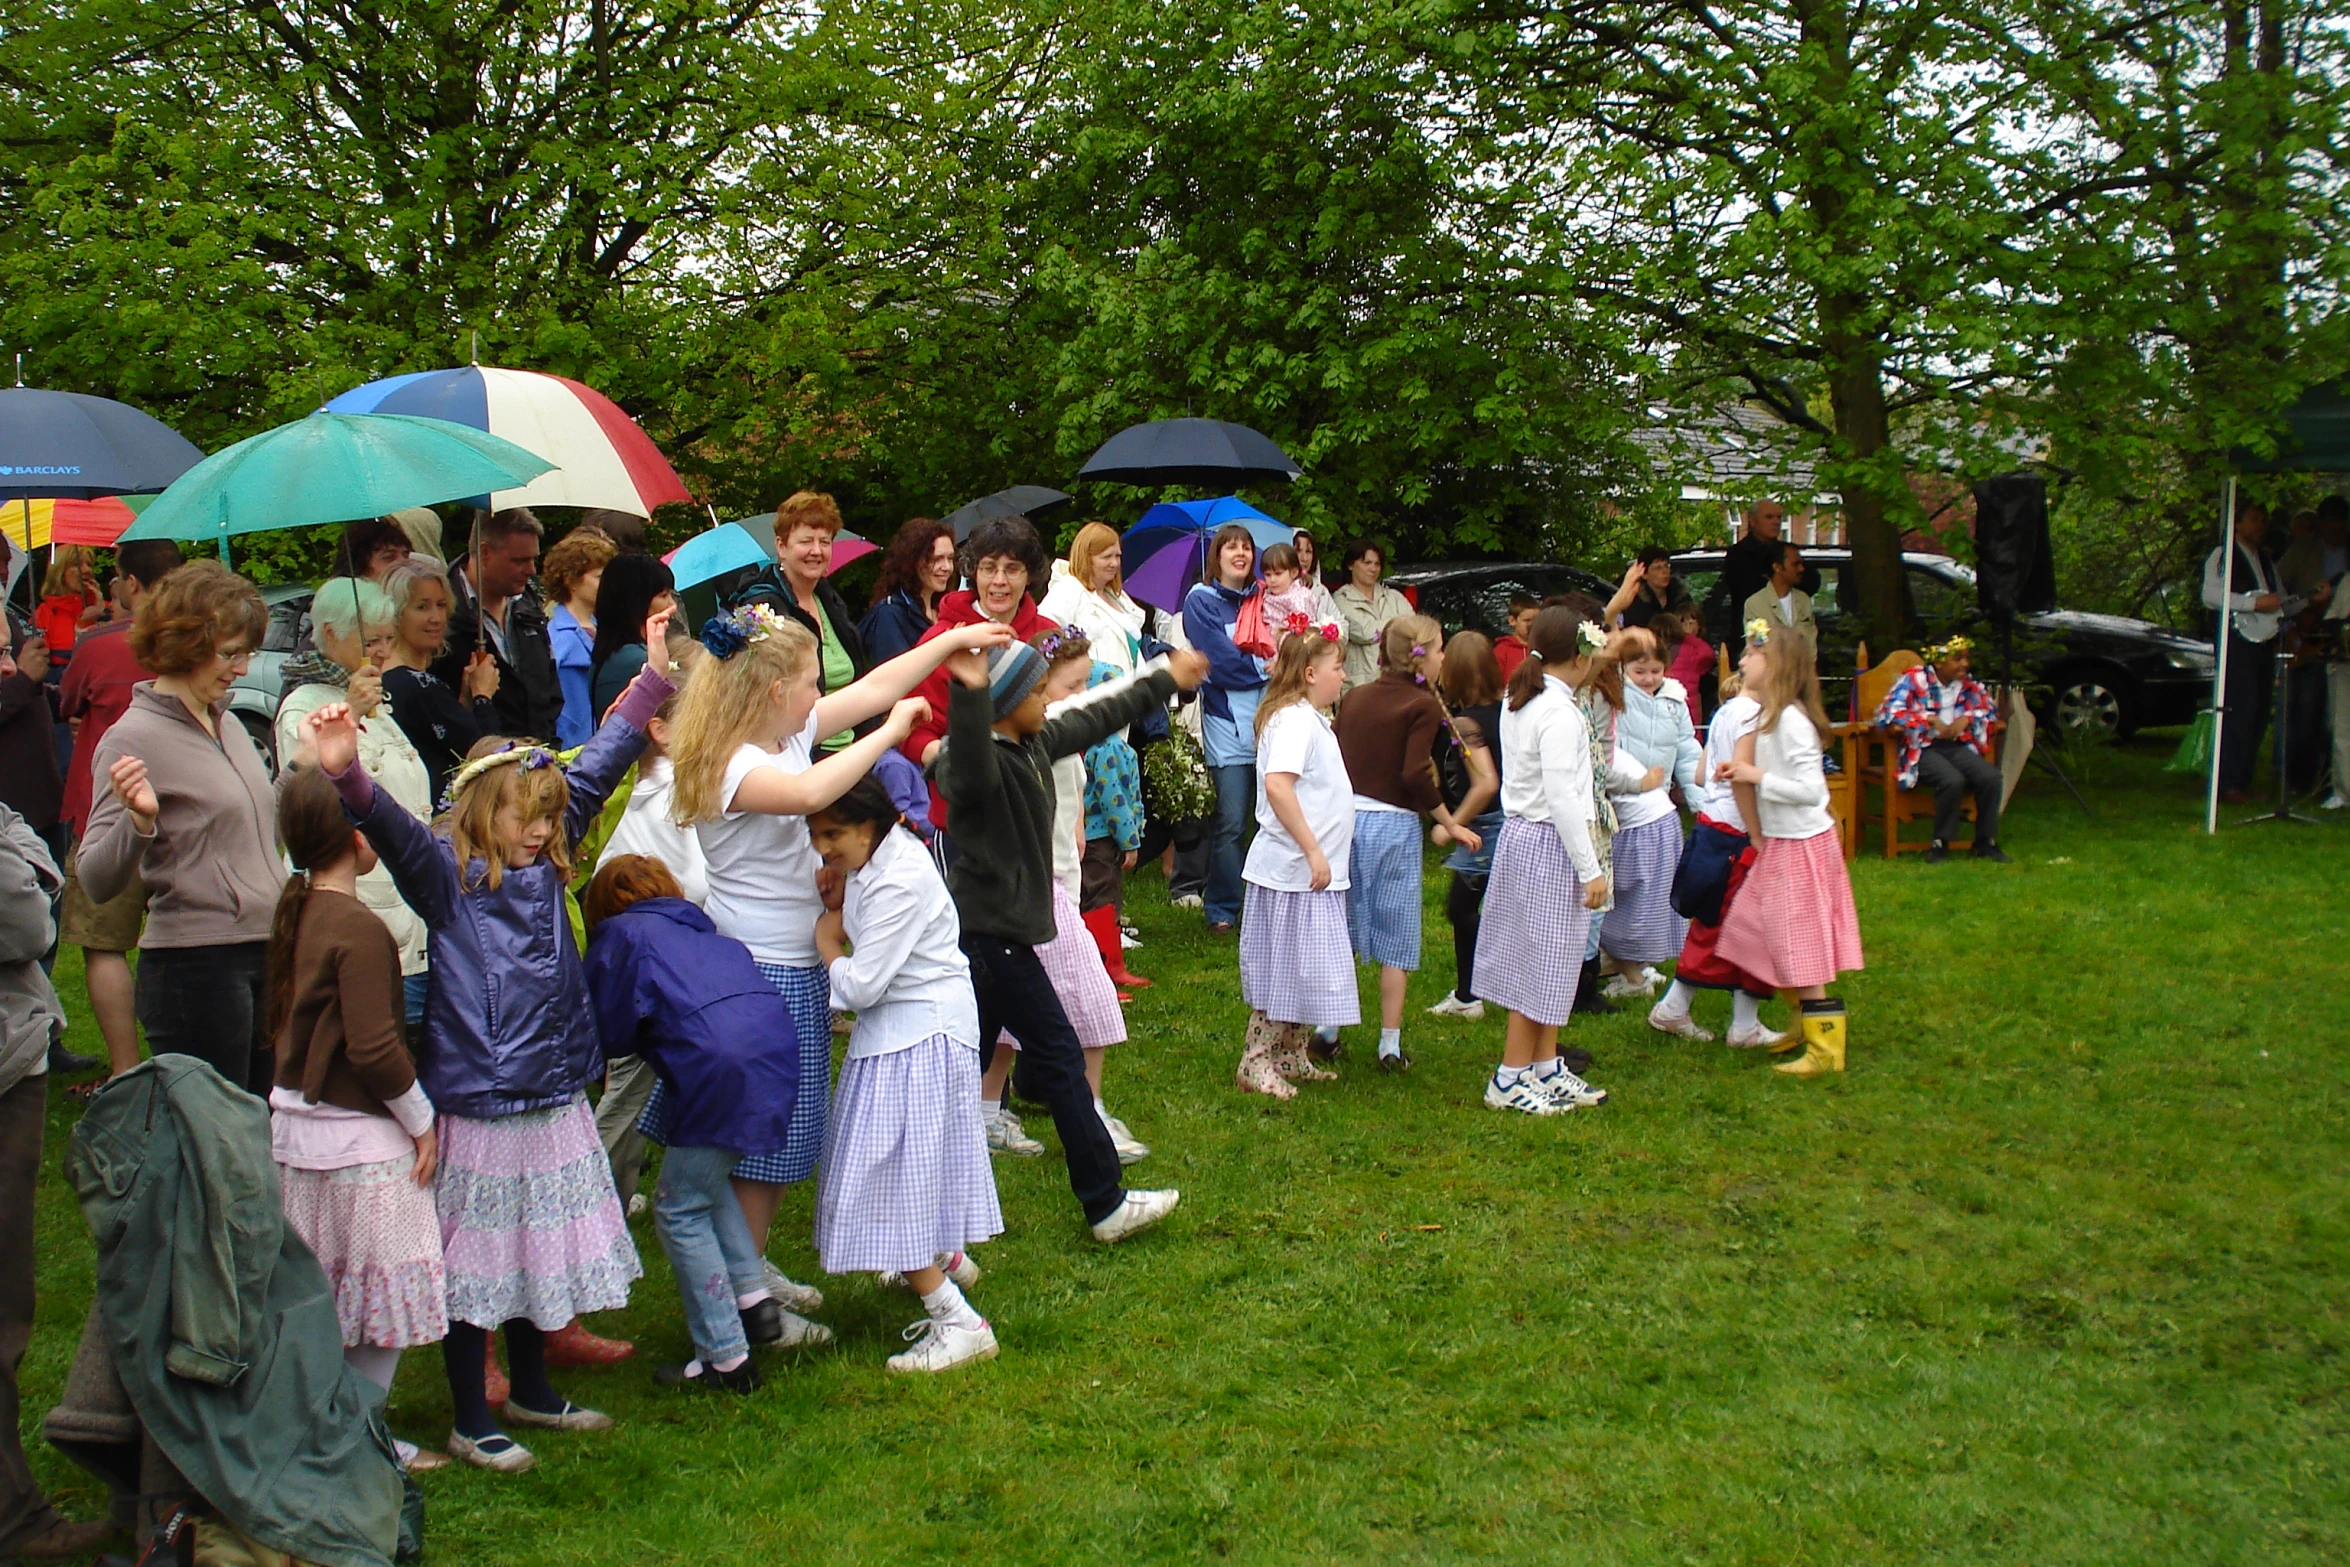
xmin=931 ymin=641 xmax=1208 ymax=1243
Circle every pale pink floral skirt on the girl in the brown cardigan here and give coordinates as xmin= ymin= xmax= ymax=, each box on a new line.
xmin=277 ymin=1154 xmax=449 ymax=1349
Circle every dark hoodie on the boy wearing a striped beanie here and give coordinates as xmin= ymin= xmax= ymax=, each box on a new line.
xmin=931 ymin=658 xmax=1175 ymax=947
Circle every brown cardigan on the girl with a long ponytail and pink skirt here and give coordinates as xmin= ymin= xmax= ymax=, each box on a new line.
xmin=277 ymin=890 xmax=416 ymax=1116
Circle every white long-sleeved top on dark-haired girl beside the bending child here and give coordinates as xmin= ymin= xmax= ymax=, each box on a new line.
xmin=832 ymin=827 xmax=980 ymax=1060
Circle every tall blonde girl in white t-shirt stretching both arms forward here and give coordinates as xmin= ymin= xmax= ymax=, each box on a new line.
xmin=644 ymin=601 xmax=1013 ymax=1315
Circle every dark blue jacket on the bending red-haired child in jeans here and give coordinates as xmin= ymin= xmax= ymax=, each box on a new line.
xmin=588 ymin=897 xmax=799 ymax=1154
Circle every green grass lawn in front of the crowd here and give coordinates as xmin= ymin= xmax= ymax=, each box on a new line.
xmin=26 ymin=735 xmax=2350 ymax=1567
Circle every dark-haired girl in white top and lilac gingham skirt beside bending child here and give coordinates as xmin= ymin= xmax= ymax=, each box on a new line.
xmin=808 ymin=778 xmax=1003 ymax=1372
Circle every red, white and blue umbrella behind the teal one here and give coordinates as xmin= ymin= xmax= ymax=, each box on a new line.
xmin=327 ymin=364 xmax=691 ymax=517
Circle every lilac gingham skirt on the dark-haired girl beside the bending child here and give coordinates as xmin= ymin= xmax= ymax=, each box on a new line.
xmin=815 ymin=1034 xmax=1003 ymax=1273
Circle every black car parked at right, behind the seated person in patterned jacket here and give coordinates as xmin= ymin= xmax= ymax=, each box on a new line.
xmin=1673 ymin=545 xmax=2211 ymax=738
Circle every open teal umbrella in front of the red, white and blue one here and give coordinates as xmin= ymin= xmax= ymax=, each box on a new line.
xmin=122 ymin=413 xmax=555 ymax=557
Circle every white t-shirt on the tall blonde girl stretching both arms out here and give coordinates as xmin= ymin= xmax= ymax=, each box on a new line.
xmin=693 ymin=712 xmax=825 ymax=968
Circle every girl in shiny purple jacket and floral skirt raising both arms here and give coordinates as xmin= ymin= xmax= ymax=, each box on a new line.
xmin=303 ymin=596 xmax=672 ymax=1473
